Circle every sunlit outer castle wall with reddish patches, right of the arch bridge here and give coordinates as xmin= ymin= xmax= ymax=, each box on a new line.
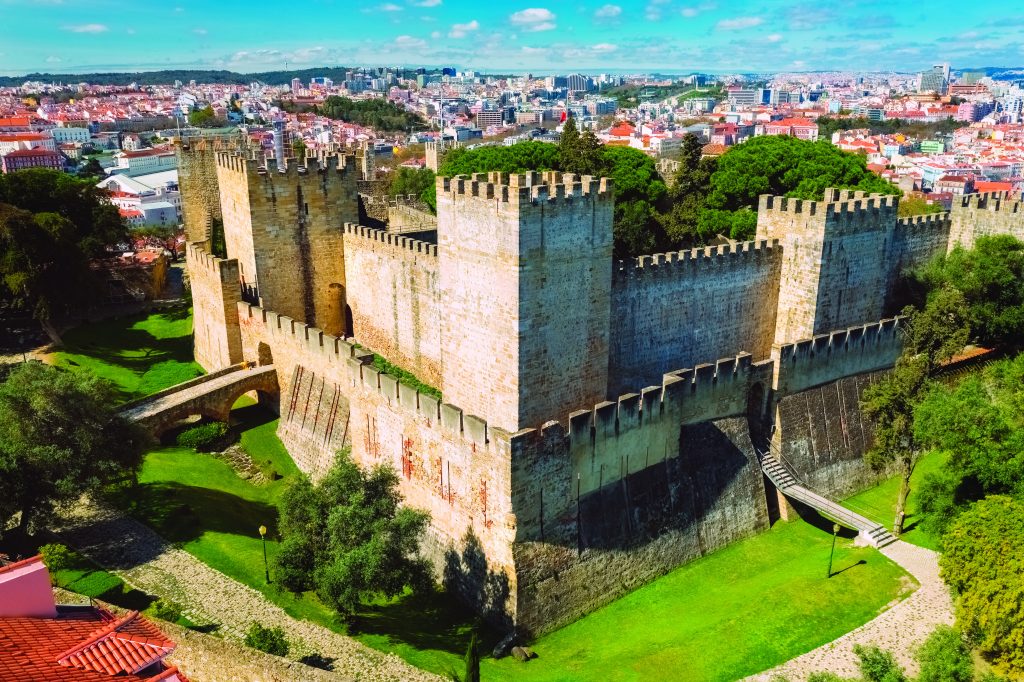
xmin=239 ymin=303 xmax=515 ymax=625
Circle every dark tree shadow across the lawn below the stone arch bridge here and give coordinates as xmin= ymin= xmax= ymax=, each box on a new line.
xmin=126 ymin=481 xmax=278 ymax=543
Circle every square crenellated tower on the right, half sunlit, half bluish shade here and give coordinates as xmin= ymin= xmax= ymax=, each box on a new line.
xmin=757 ymin=189 xmax=897 ymax=343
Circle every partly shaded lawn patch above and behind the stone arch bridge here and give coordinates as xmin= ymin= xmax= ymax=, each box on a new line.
xmin=53 ymin=307 xmax=203 ymax=400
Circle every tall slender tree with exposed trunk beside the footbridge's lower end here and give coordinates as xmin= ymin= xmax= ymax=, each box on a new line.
xmin=863 ymin=291 xmax=968 ymax=536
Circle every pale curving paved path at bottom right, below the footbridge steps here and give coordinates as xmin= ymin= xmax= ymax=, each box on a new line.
xmin=748 ymin=541 xmax=953 ymax=682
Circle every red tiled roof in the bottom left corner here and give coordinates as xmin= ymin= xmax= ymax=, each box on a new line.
xmin=0 ymin=606 xmax=185 ymax=682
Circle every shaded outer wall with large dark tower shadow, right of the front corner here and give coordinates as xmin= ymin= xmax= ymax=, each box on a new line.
xmin=512 ymin=355 xmax=772 ymax=633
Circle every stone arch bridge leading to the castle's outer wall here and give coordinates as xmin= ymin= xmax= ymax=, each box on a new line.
xmin=121 ymin=364 xmax=278 ymax=436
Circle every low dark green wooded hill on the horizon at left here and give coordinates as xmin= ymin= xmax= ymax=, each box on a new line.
xmin=0 ymin=67 xmax=440 ymax=87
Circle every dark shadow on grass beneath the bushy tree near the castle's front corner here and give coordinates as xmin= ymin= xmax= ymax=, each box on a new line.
xmin=348 ymin=588 xmax=501 ymax=656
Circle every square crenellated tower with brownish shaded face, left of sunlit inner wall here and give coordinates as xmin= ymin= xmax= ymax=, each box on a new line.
xmin=217 ymin=152 xmax=358 ymax=335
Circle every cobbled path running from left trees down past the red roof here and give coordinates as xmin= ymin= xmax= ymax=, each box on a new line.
xmin=59 ymin=505 xmax=438 ymax=682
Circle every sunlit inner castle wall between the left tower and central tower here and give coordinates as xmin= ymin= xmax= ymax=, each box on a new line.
xmin=345 ymin=224 xmax=442 ymax=386
